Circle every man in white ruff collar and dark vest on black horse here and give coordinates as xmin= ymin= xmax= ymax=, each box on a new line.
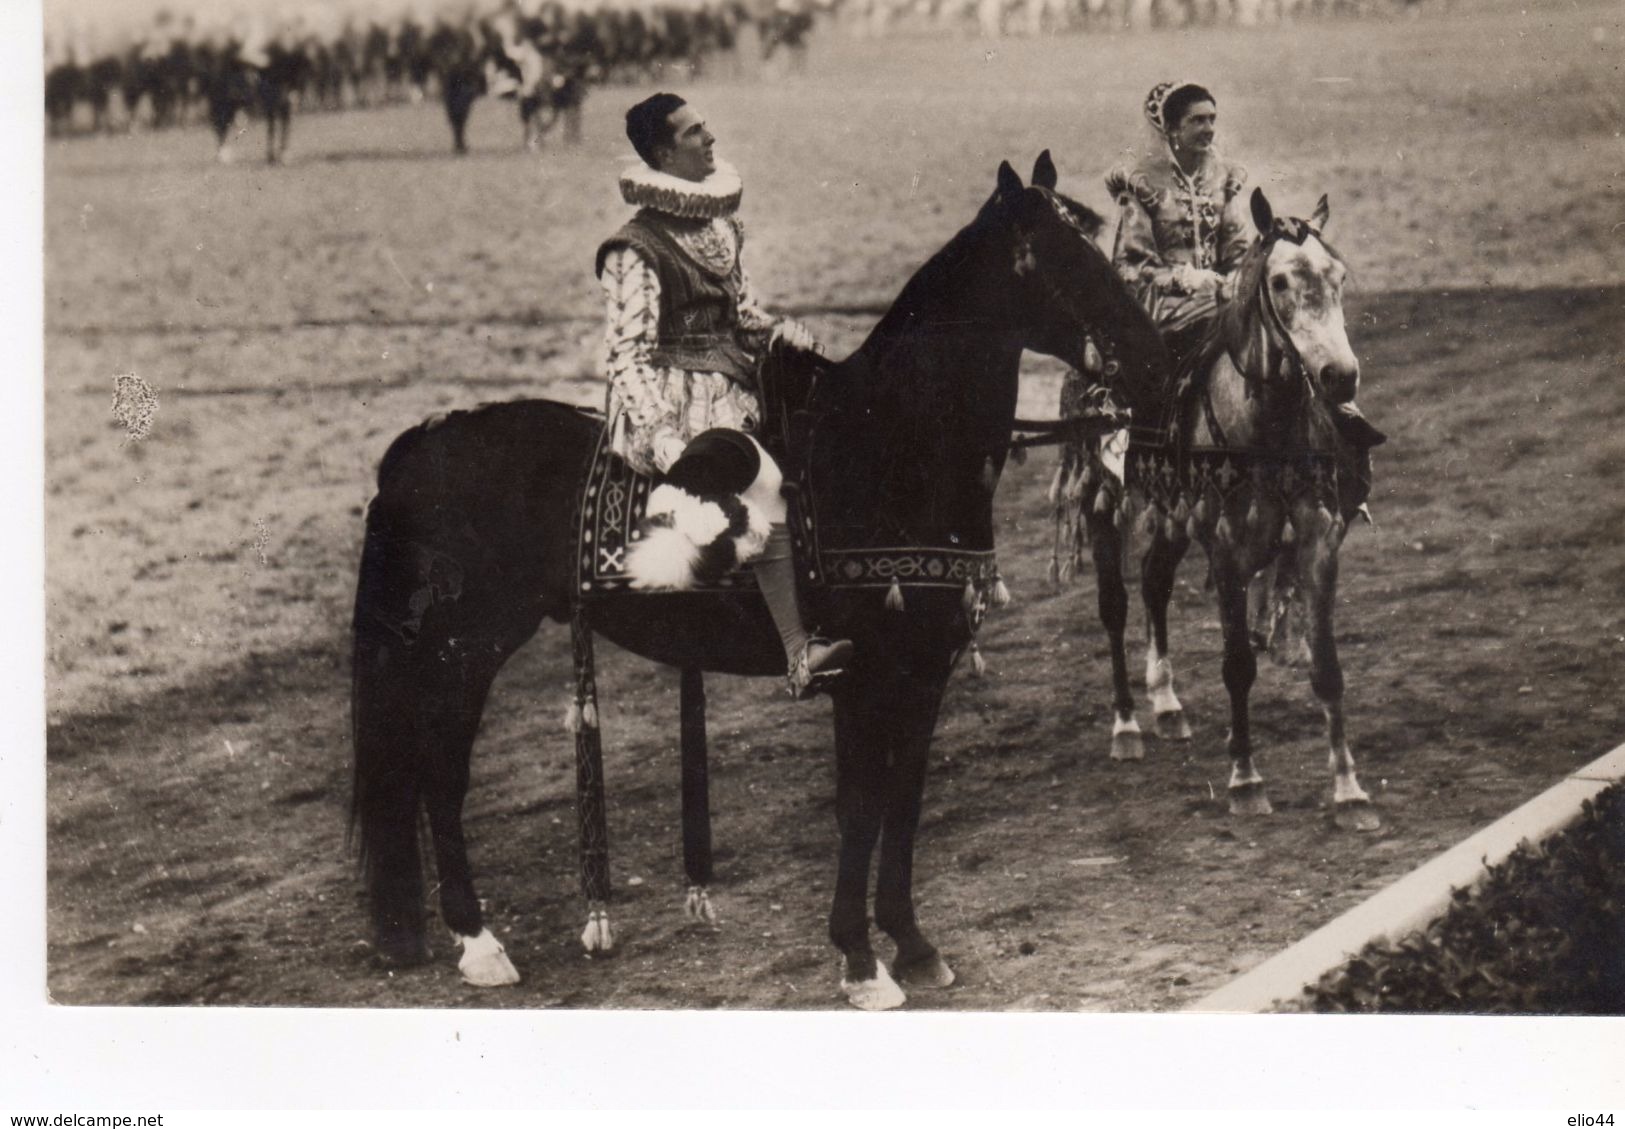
xmin=598 ymin=94 xmax=852 ymax=697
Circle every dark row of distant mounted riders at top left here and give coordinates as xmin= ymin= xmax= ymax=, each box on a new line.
xmin=46 ymin=0 xmax=814 ymax=161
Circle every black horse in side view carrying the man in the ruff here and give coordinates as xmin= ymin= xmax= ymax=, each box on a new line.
xmin=351 ymin=153 xmax=1167 ymax=1009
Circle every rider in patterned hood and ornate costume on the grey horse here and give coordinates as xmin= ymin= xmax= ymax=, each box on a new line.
xmin=1107 ymin=83 xmax=1385 ymax=448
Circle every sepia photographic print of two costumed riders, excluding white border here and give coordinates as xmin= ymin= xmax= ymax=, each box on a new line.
xmin=28 ymin=0 xmax=1625 ymax=1039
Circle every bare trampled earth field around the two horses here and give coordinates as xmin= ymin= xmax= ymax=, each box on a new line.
xmin=46 ymin=5 xmax=1625 ymax=1012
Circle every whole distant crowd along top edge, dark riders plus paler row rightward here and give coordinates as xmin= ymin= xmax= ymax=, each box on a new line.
xmin=46 ymin=0 xmax=1423 ymax=161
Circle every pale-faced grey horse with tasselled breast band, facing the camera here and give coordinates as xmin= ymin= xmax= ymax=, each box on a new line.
xmin=1056 ymin=190 xmax=1378 ymax=830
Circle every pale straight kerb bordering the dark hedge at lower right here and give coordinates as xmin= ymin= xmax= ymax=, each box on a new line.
xmin=1183 ymin=744 xmax=1625 ymax=1012
